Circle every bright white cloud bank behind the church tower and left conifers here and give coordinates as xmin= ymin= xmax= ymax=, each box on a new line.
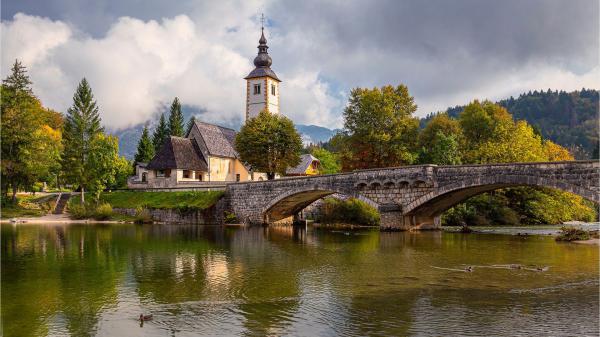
xmin=2 ymin=9 xmax=339 ymax=129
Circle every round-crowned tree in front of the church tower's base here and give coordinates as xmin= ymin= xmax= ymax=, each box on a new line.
xmin=235 ymin=110 xmax=302 ymax=180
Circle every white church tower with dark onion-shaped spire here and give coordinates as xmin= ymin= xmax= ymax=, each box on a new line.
xmin=244 ymin=20 xmax=281 ymax=120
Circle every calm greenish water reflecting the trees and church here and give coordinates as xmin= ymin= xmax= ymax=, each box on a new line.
xmin=1 ymin=225 xmax=599 ymax=336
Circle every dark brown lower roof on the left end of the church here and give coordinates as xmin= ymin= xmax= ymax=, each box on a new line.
xmin=146 ymin=136 xmax=208 ymax=171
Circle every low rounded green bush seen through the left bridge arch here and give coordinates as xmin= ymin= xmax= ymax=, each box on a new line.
xmin=320 ymin=197 xmax=381 ymax=226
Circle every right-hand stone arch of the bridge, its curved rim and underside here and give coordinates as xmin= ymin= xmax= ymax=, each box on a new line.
xmin=403 ymin=175 xmax=600 ymax=216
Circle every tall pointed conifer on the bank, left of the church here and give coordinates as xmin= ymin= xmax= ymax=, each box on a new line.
xmin=63 ymin=78 xmax=104 ymax=204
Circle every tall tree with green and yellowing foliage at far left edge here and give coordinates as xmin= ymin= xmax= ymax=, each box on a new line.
xmin=0 ymin=60 xmax=62 ymax=202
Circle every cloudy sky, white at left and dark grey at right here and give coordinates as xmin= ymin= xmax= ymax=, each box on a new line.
xmin=0 ymin=0 xmax=600 ymax=130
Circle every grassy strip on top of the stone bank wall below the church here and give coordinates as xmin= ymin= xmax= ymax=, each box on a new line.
xmin=100 ymin=191 xmax=224 ymax=211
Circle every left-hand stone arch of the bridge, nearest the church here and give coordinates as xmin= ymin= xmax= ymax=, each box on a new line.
xmin=261 ymin=186 xmax=378 ymax=223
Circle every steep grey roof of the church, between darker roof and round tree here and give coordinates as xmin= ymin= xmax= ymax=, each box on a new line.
xmin=196 ymin=121 xmax=238 ymax=158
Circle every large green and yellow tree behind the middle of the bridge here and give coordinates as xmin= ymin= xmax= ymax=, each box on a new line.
xmin=341 ymin=85 xmax=419 ymax=171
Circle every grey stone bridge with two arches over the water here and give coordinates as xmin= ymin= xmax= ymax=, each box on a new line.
xmin=225 ymin=161 xmax=600 ymax=230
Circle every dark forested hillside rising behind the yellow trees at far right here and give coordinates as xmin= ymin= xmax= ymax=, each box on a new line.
xmin=421 ymin=89 xmax=599 ymax=159
